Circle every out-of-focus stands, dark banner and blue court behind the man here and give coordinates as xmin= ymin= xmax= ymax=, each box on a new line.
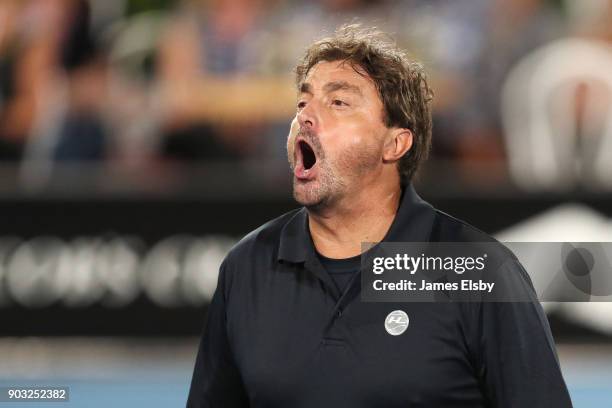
xmin=0 ymin=0 xmax=612 ymax=407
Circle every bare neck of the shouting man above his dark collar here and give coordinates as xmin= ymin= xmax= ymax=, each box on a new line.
xmin=308 ymin=180 xmax=401 ymax=258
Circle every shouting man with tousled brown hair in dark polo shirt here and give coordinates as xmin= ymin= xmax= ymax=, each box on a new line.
xmin=187 ymin=26 xmax=571 ymax=408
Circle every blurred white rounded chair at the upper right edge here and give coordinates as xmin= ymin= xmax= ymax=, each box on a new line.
xmin=502 ymin=0 xmax=612 ymax=190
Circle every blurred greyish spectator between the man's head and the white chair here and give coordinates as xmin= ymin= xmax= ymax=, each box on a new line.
xmin=392 ymin=0 xmax=563 ymax=164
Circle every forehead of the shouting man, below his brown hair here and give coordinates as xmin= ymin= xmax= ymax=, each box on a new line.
xmin=304 ymin=61 xmax=378 ymax=97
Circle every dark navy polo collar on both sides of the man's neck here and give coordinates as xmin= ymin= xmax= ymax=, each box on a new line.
xmin=278 ymin=184 xmax=435 ymax=263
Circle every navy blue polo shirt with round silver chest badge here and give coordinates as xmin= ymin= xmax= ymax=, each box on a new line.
xmin=187 ymin=186 xmax=571 ymax=408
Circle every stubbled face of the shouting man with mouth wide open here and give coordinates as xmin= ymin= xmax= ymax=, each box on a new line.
xmin=287 ymin=61 xmax=389 ymax=208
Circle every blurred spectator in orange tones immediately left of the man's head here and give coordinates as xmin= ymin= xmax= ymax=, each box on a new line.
xmin=159 ymin=0 xmax=294 ymax=160
